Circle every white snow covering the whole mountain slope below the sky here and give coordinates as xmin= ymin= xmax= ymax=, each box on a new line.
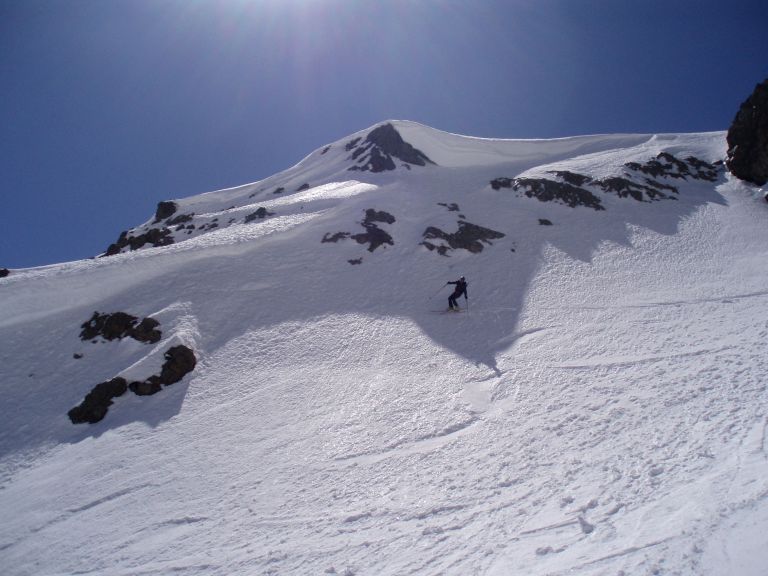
xmin=0 ymin=122 xmax=768 ymax=576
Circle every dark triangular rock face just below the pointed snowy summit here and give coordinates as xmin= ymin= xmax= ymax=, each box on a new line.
xmin=345 ymin=124 xmax=434 ymax=172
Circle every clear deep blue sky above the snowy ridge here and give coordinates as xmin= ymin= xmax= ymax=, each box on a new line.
xmin=0 ymin=0 xmax=768 ymax=268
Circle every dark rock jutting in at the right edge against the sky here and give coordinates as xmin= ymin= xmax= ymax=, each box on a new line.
xmin=726 ymin=80 xmax=768 ymax=186
